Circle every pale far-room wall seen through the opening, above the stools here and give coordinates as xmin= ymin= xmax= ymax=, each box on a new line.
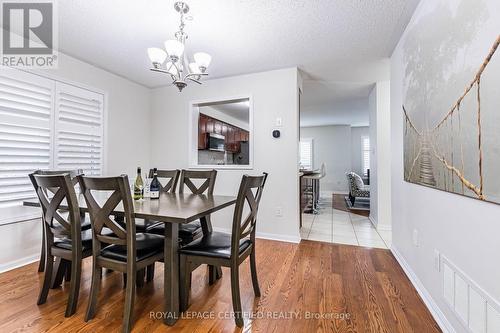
xmin=300 ymin=125 xmax=352 ymax=195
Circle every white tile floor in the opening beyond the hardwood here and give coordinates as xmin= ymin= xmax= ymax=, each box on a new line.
xmin=300 ymin=198 xmax=392 ymax=249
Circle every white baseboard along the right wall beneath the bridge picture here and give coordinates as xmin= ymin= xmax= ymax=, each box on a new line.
xmin=391 ymin=245 xmax=456 ymax=333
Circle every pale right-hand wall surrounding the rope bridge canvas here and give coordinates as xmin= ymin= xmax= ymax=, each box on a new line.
xmin=391 ymin=0 xmax=500 ymax=332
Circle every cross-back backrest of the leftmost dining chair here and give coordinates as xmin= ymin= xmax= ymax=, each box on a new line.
xmin=29 ymin=173 xmax=81 ymax=244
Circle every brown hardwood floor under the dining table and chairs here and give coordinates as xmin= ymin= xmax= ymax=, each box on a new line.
xmin=0 ymin=239 xmax=441 ymax=333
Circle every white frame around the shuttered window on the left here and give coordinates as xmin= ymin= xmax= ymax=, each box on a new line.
xmin=0 ymin=67 xmax=109 ymax=226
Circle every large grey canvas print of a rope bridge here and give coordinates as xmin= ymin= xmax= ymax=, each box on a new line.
xmin=401 ymin=0 xmax=500 ymax=203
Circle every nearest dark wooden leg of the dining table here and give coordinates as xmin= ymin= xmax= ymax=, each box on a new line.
xmin=163 ymin=223 xmax=179 ymax=326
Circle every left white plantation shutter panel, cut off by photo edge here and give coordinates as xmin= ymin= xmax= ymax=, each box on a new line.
xmin=0 ymin=68 xmax=55 ymax=208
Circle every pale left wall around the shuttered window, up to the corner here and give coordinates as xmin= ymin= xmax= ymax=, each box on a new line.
xmin=0 ymin=53 xmax=150 ymax=271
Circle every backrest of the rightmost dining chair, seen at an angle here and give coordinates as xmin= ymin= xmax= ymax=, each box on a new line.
xmin=231 ymin=172 xmax=267 ymax=258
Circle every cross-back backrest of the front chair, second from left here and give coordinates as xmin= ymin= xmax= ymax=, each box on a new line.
xmin=78 ymin=175 xmax=135 ymax=249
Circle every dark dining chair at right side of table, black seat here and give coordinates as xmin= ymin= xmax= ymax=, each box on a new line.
xmin=179 ymin=173 xmax=267 ymax=327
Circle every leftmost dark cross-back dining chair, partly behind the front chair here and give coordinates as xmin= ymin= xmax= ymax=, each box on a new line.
xmin=29 ymin=173 xmax=92 ymax=317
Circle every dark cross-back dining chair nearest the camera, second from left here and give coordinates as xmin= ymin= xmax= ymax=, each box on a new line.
xmin=78 ymin=175 xmax=164 ymax=332
